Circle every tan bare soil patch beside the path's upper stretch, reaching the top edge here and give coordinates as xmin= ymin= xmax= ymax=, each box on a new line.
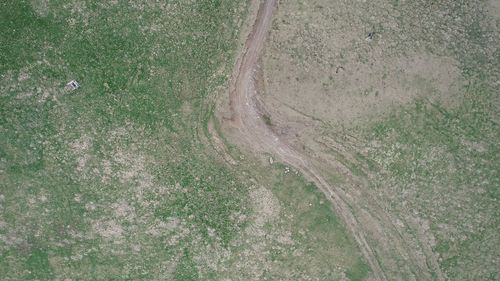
xmin=262 ymin=0 xmax=462 ymax=126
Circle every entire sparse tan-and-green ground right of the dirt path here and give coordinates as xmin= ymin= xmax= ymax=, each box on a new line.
xmin=264 ymin=0 xmax=500 ymax=280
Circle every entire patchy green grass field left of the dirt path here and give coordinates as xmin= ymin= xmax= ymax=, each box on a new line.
xmin=0 ymin=0 xmax=369 ymax=280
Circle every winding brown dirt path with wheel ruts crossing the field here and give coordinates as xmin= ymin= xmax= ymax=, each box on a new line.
xmin=230 ymin=0 xmax=386 ymax=280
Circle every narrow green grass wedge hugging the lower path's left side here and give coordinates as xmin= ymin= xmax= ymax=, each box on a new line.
xmin=260 ymin=164 xmax=370 ymax=280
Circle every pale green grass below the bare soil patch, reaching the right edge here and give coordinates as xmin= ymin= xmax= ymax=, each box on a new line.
xmin=369 ymin=89 xmax=500 ymax=279
